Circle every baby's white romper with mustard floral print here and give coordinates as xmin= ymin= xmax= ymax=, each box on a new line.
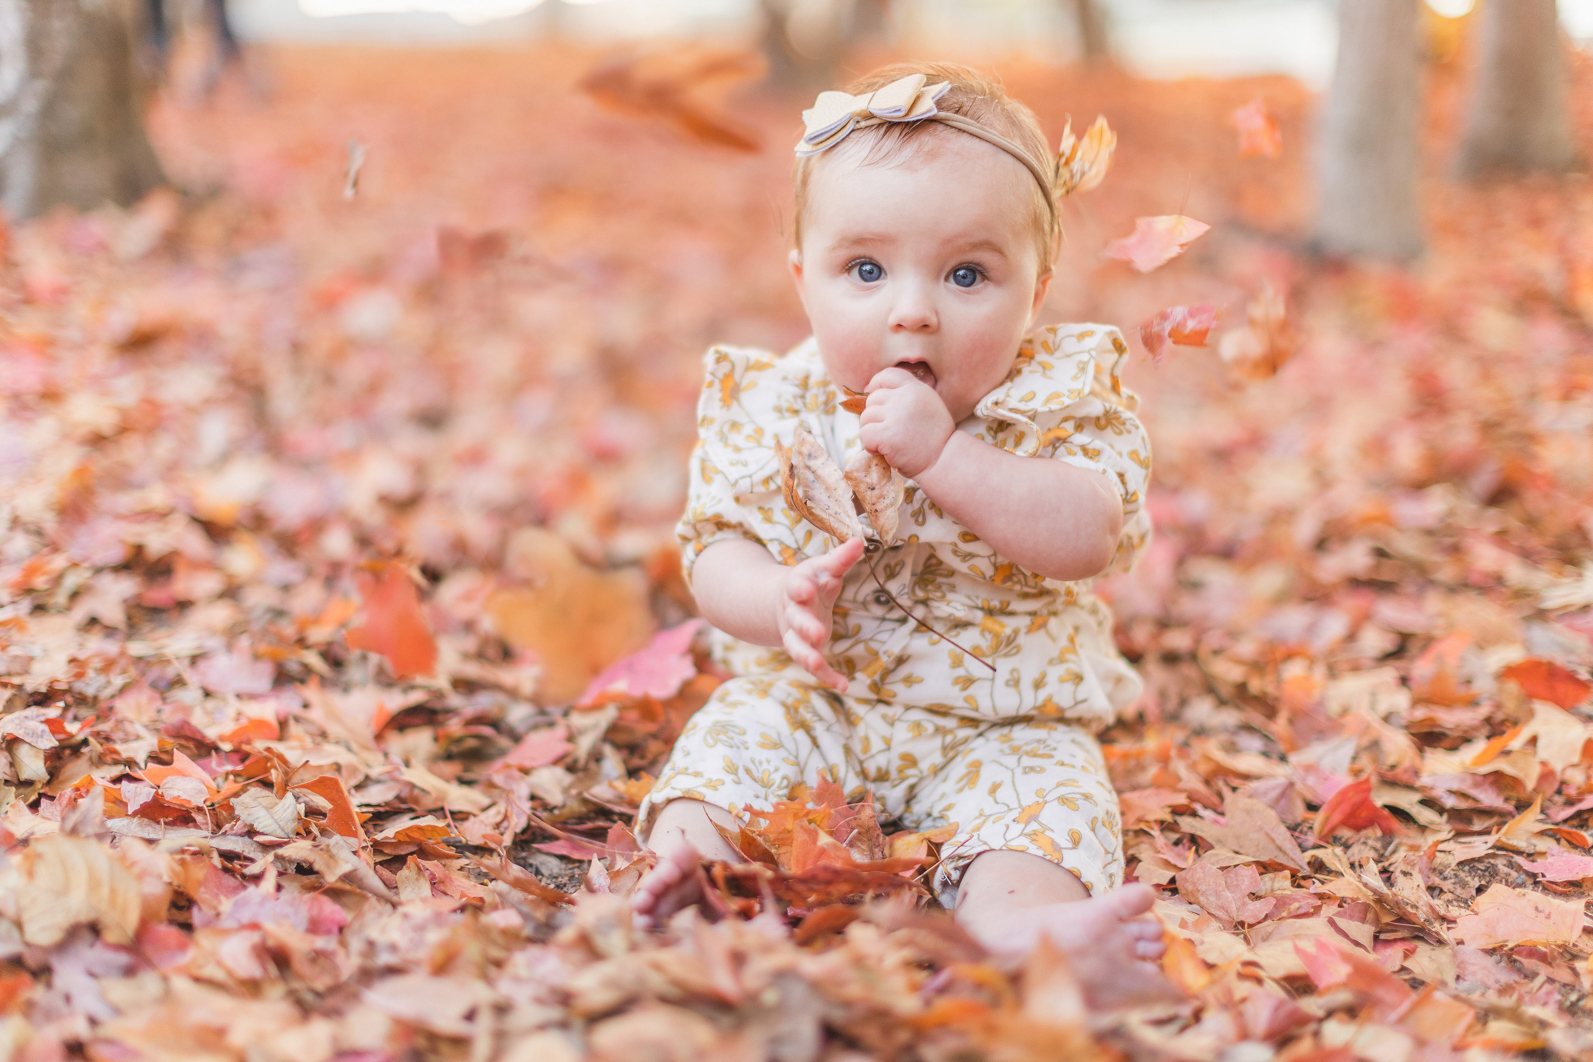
xmin=639 ymin=325 xmax=1150 ymax=901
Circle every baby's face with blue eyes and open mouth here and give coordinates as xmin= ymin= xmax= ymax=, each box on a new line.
xmin=790 ymin=134 xmax=1050 ymax=420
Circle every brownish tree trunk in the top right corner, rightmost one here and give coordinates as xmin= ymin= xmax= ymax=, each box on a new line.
xmin=1456 ymin=0 xmax=1577 ymax=177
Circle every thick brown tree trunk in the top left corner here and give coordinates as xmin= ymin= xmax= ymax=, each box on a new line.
xmin=0 ymin=0 xmax=164 ymax=218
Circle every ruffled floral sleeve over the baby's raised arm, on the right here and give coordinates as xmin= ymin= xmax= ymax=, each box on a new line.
xmin=977 ymin=325 xmax=1150 ymax=572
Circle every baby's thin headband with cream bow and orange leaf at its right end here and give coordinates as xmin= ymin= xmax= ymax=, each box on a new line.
xmin=797 ymin=73 xmax=1117 ymax=230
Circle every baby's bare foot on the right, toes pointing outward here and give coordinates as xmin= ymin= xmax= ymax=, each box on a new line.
xmin=980 ymin=884 xmax=1182 ymax=1009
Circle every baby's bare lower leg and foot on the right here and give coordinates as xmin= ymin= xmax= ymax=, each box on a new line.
xmin=957 ymin=850 xmax=1179 ymax=1008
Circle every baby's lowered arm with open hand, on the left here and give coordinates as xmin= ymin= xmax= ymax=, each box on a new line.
xmin=691 ymin=538 xmax=863 ymax=689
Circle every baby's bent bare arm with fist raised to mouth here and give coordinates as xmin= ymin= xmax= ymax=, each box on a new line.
xmin=862 ymin=368 xmax=1123 ymax=580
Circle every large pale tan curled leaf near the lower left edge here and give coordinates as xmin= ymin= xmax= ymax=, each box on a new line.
xmin=18 ymin=833 xmax=142 ymax=947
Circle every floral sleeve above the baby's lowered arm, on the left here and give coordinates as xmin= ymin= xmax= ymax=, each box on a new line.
xmin=675 ymin=347 xmax=785 ymax=584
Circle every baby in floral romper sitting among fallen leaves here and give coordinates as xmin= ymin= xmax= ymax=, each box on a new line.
xmin=632 ymin=65 xmax=1171 ymax=1006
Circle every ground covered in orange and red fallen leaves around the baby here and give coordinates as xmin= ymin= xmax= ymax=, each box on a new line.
xmin=0 ymin=37 xmax=1593 ymax=1062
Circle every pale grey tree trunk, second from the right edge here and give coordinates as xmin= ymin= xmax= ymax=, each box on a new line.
xmin=1316 ymin=0 xmax=1427 ymax=260
